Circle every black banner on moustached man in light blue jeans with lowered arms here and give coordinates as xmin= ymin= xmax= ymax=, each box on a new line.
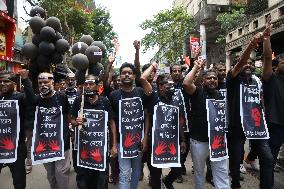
xmin=119 ymin=97 xmax=144 ymax=158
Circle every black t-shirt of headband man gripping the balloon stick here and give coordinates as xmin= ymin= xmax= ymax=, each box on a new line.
xmin=70 ymin=96 xmax=113 ymax=120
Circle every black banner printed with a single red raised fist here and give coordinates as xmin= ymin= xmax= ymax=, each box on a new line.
xmin=240 ymin=85 xmax=269 ymax=139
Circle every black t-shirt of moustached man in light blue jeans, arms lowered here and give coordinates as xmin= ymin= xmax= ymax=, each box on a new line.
xmin=109 ymin=87 xmax=147 ymax=143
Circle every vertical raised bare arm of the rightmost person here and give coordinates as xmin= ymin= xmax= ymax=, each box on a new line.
xmin=262 ymin=22 xmax=273 ymax=81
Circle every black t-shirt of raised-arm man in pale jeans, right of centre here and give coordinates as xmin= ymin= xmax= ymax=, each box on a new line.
xmin=189 ymin=87 xmax=220 ymax=142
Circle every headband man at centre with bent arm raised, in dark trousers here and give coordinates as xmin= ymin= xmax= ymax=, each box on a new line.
xmin=140 ymin=63 xmax=186 ymax=189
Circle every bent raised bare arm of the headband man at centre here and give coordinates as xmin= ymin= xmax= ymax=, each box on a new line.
xmin=140 ymin=63 xmax=158 ymax=96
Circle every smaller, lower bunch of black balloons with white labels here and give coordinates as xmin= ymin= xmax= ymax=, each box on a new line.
xmin=71 ymin=35 xmax=106 ymax=83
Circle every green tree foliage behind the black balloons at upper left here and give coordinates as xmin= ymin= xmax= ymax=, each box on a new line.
xmin=38 ymin=0 xmax=116 ymax=53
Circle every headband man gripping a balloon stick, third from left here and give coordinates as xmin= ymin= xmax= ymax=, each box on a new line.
xmin=71 ymin=75 xmax=117 ymax=189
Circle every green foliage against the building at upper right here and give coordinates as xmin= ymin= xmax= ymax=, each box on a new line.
xmin=216 ymin=7 xmax=246 ymax=43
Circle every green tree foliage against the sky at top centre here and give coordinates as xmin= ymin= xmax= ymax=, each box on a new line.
xmin=140 ymin=7 xmax=195 ymax=63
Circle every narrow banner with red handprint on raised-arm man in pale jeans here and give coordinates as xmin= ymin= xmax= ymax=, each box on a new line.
xmin=206 ymin=99 xmax=229 ymax=161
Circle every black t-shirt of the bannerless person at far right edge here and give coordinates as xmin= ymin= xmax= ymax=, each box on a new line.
xmin=263 ymin=74 xmax=284 ymax=126
